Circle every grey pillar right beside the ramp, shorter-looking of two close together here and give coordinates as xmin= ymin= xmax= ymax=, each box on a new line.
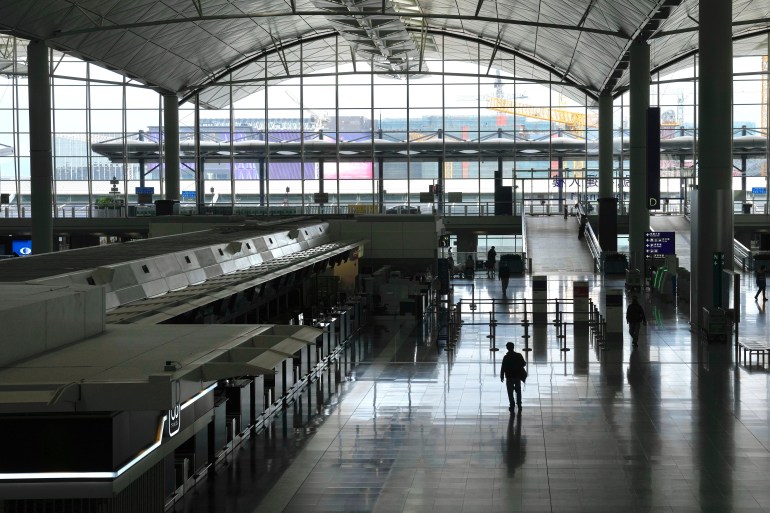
xmin=599 ymin=93 xmax=618 ymax=251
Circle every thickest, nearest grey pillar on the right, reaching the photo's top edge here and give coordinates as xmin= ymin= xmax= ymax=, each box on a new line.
xmin=690 ymin=0 xmax=733 ymax=326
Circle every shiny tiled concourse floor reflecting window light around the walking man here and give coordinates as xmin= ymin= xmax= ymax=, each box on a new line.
xmin=172 ymin=275 xmax=770 ymax=513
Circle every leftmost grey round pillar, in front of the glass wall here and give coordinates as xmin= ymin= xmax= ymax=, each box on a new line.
xmin=27 ymin=41 xmax=53 ymax=255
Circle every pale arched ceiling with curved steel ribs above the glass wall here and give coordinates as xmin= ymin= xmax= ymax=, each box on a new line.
xmin=0 ymin=0 xmax=770 ymax=106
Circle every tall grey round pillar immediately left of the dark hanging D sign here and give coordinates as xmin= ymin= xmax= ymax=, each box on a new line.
xmin=628 ymin=41 xmax=650 ymax=270
